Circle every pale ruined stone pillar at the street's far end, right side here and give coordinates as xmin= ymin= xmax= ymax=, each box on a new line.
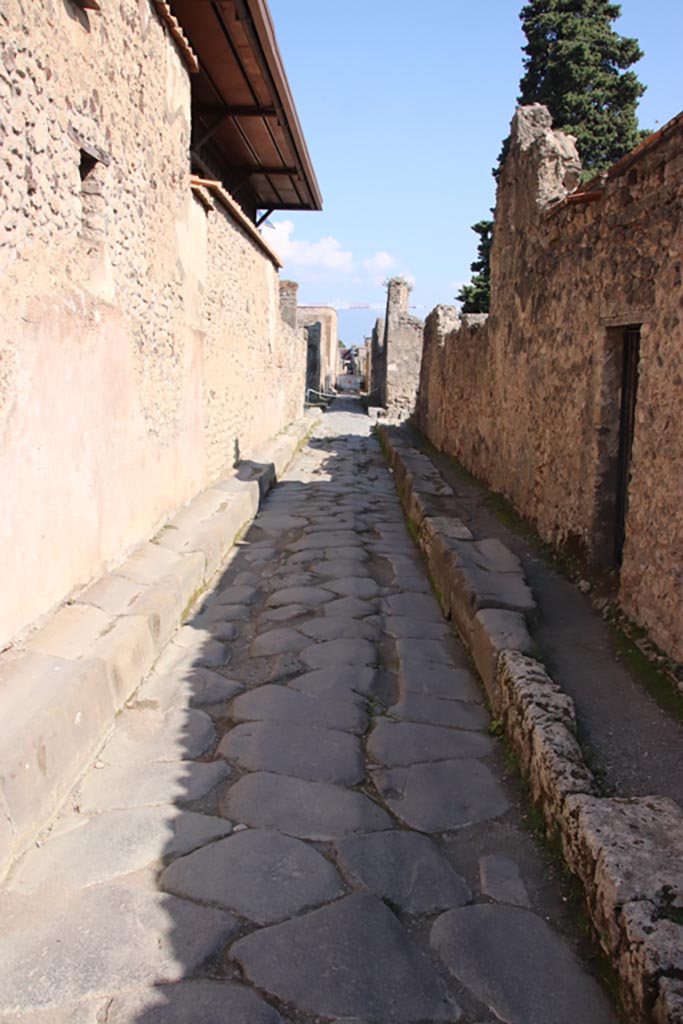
xmin=383 ymin=278 xmax=424 ymax=419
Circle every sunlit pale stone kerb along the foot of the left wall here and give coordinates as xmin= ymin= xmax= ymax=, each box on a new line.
xmin=0 ymin=411 xmax=322 ymax=880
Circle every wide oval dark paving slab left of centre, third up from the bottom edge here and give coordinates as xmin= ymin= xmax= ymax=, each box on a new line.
xmin=220 ymin=772 xmax=391 ymax=843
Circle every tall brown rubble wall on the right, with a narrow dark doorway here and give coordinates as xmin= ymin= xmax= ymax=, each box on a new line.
xmin=417 ymin=105 xmax=683 ymax=658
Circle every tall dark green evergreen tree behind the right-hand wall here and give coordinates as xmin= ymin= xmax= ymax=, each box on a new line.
xmin=458 ymin=0 xmax=647 ymax=312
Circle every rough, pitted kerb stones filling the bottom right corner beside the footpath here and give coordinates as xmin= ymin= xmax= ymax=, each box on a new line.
xmin=562 ymin=796 xmax=683 ymax=1024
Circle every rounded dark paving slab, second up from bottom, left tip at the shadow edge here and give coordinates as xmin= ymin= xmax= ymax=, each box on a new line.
xmin=161 ymin=828 xmax=343 ymax=925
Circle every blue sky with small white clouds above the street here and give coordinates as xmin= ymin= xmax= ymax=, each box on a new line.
xmin=264 ymin=0 xmax=683 ymax=344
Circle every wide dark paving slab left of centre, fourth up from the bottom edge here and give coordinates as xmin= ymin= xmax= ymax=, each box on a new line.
xmin=218 ymin=722 xmax=366 ymax=785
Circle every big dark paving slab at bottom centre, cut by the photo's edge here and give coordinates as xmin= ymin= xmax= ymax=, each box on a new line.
xmin=231 ymin=895 xmax=459 ymax=1024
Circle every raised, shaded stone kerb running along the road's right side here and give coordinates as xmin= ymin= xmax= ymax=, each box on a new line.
xmin=378 ymin=426 xmax=683 ymax=1024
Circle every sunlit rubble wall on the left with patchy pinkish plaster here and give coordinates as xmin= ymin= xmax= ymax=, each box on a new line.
xmin=0 ymin=0 xmax=305 ymax=644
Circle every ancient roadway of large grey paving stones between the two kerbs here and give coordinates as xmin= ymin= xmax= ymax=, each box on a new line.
xmin=0 ymin=403 xmax=616 ymax=1024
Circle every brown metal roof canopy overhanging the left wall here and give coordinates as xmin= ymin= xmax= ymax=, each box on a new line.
xmin=172 ymin=0 xmax=323 ymax=217
